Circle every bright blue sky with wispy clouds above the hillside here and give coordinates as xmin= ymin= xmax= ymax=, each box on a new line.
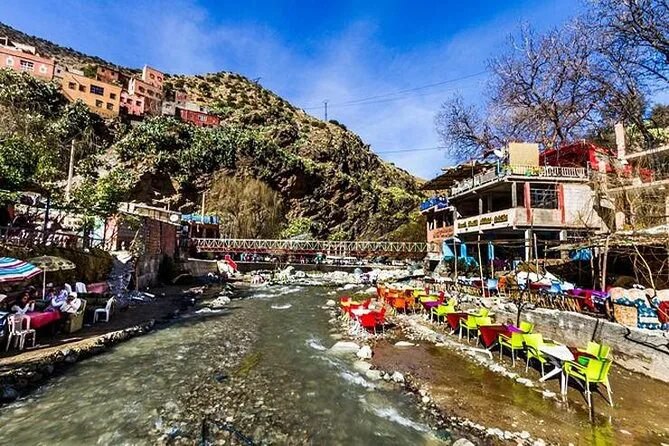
xmin=0 ymin=0 xmax=581 ymax=178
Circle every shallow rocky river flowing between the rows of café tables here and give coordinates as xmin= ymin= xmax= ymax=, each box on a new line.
xmin=0 ymin=287 xmax=457 ymax=445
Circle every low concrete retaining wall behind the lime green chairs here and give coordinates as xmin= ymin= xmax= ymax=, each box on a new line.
xmin=494 ymin=308 xmax=669 ymax=384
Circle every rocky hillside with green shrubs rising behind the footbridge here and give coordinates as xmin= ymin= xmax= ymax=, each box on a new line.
xmin=0 ymin=21 xmax=424 ymax=240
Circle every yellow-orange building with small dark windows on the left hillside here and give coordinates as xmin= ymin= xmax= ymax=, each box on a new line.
xmin=60 ymin=71 xmax=121 ymax=118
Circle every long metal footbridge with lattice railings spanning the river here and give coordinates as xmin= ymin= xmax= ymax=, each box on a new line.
xmin=191 ymin=238 xmax=427 ymax=257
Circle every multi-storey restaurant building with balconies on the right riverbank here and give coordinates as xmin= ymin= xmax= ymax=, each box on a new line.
xmin=421 ymin=143 xmax=606 ymax=264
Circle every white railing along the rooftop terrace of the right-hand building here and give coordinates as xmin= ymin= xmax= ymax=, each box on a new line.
xmin=451 ymin=165 xmax=588 ymax=196
